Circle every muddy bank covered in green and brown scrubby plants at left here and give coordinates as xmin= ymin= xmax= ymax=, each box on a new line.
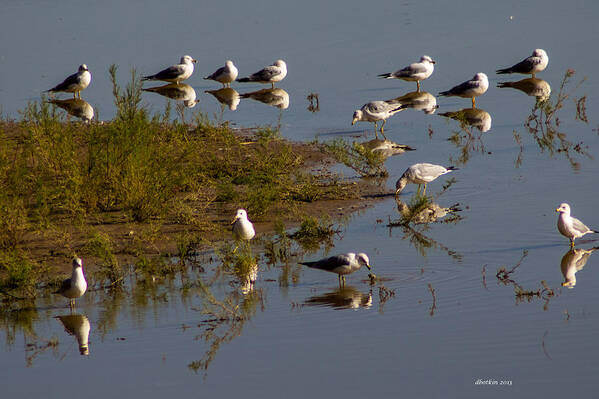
xmin=0 ymin=65 xmax=352 ymax=296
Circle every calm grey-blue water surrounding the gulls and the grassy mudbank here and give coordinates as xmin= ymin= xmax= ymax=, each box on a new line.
xmin=0 ymin=1 xmax=599 ymax=398
